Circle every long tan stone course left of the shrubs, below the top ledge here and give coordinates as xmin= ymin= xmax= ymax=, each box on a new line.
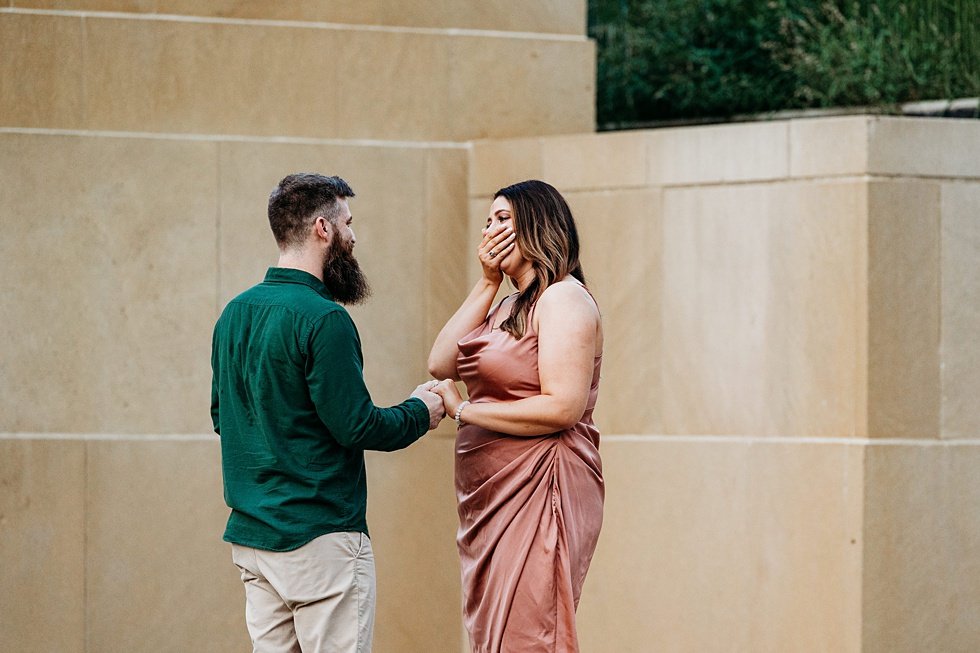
xmin=21 ymin=14 xmax=595 ymax=141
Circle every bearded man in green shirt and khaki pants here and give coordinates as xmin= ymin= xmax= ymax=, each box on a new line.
xmin=211 ymin=174 xmax=444 ymax=653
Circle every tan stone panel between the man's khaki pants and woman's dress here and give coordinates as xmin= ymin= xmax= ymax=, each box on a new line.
xmin=367 ymin=436 xmax=462 ymax=653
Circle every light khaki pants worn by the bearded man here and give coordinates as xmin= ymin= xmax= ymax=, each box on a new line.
xmin=231 ymin=533 xmax=375 ymax=653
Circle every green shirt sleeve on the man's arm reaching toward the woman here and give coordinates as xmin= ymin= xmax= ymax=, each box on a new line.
xmin=306 ymin=310 xmax=429 ymax=451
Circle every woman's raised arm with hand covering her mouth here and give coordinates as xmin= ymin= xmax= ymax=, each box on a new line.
xmin=429 ymin=227 xmax=514 ymax=380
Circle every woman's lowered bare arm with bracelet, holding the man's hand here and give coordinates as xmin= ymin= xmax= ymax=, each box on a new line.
xmin=433 ymin=282 xmax=602 ymax=436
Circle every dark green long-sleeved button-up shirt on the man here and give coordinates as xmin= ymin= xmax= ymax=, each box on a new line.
xmin=211 ymin=268 xmax=429 ymax=551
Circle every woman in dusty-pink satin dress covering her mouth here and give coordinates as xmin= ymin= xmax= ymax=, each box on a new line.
xmin=429 ymin=181 xmax=603 ymax=653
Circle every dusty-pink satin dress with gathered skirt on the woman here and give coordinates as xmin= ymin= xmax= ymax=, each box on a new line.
xmin=455 ymin=298 xmax=604 ymax=653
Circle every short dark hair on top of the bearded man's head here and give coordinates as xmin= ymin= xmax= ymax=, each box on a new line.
xmin=269 ymin=172 xmax=354 ymax=248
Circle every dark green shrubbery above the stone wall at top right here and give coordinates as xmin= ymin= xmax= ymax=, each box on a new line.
xmin=589 ymin=0 xmax=980 ymax=128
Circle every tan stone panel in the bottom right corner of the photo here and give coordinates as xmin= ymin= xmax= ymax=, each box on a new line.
xmin=861 ymin=445 xmax=980 ymax=653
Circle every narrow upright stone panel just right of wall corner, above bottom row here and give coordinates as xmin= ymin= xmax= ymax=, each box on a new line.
xmin=868 ymin=181 xmax=941 ymax=437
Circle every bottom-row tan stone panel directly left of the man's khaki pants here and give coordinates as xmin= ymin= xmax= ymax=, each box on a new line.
xmin=85 ymin=440 xmax=249 ymax=653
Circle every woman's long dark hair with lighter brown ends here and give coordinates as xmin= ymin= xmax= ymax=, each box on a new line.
xmin=493 ymin=179 xmax=585 ymax=338
